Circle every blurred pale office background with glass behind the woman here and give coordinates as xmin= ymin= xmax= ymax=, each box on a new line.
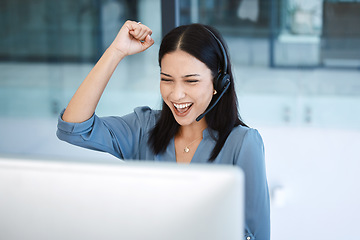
xmin=0 ymin=0 xmax=360 ymax=240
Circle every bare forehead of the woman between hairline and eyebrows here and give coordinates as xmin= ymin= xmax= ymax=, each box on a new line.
xmin=161 ymin=50 xmax=211 ymax=73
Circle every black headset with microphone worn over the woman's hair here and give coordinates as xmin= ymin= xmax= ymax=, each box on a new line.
xmin=196 ymin=27 xmax=230 ymax=121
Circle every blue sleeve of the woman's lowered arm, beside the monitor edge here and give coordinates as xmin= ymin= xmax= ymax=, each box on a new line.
xmin=236 ymin=129 xmax=270 ymax=240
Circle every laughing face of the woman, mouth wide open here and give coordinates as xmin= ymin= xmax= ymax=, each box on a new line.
xmin=160 ymin=50 xmax=214 ymax=126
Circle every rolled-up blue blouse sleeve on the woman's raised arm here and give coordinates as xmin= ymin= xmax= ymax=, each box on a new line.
xmin=56 ymin=107 xmax=152 ymax=159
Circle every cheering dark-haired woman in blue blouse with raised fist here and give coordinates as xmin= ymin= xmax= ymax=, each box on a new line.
xmin=57 ymin=21 xmax=270 ymax=239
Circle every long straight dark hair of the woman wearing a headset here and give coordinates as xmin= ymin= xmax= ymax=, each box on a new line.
xmin=149 ymin=24 xmax=246 ymax=161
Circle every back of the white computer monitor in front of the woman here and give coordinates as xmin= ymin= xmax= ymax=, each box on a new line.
xmin=0 ymin=158 xmax=244 ymax=240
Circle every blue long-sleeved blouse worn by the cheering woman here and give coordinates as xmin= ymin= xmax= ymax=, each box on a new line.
xmin=57 ymin=107 xmax=270 ymax=240
